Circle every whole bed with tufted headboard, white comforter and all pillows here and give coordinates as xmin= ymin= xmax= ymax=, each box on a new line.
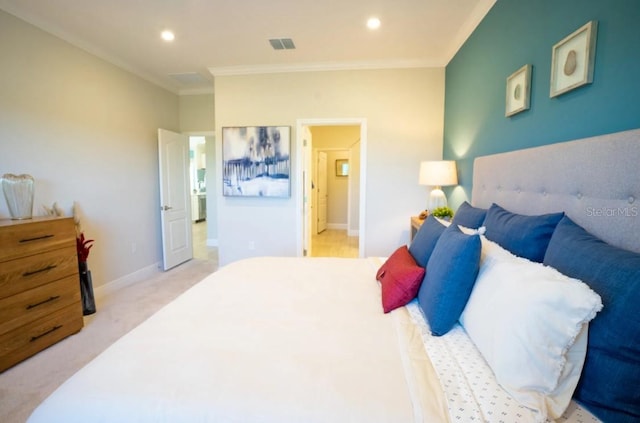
xmin=29 ymin=130 xmax=640 ymax=423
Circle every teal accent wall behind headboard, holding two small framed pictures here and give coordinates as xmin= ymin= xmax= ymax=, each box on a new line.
xmin=443 ymin=0 xmax=640 ymax=208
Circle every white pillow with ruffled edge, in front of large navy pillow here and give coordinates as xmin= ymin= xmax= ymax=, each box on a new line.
xmin=460 ymin=237 xmax=602 ymax=421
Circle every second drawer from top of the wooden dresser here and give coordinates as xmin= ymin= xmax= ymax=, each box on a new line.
xmin=0 ymin=247 xmax=78 ymax=298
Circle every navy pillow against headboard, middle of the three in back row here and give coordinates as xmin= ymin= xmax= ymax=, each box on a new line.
xmin=484 ymin=204 xmax=564 ymax=263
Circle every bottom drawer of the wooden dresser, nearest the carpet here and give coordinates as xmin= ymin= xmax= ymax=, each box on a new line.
xmin=0 ymin=304 xmax=83 ymax=372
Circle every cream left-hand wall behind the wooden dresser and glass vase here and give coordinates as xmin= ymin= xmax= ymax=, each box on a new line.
xmin=0 ymin=11 xmax=179 ymax=286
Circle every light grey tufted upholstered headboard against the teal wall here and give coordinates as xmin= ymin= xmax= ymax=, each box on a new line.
xmin=472 ymin=129 xmax=640 ymax=252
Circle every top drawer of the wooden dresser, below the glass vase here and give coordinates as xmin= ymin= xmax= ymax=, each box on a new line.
xmin=0 ymin=217 xmax=76 ymax=262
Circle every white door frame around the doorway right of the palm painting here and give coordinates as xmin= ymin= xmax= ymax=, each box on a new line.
xmin=296 ymin=118 xmax=367 ymax=257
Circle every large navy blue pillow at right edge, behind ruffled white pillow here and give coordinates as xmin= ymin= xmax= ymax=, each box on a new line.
xmin=544 ymin=216 xmax=640 ymax=422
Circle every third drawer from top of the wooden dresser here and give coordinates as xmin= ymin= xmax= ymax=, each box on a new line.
xmin=0 ymin=274 xmax=82 ymax=334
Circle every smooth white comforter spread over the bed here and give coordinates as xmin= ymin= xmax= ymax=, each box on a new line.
xmin=29 ymin=258 xmax=448 ymax=423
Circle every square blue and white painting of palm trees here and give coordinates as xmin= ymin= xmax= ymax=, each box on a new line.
xmin=222 ymin=126 xmax=291 ymax=197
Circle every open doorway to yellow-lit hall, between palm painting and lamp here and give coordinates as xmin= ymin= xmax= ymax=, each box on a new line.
xmin=298 ymin=119 xmax=366 ymax=257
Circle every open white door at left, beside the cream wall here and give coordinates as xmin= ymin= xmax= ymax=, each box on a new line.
xmin=158 ymin=129 xmax=193 ymax=270
